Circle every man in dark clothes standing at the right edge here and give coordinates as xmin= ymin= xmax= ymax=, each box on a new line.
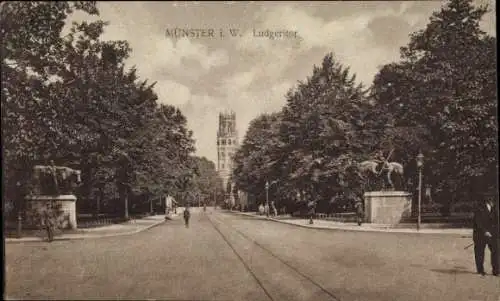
xmin=473 ymin=196 xmax=500 ymax=276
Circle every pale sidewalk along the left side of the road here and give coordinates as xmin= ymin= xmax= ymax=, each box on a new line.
xmin=4 ymin=215 xmax=178 ymax=243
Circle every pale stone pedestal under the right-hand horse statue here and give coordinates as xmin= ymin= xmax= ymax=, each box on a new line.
xmin=364 ymin=191 xmax=411 ymax=225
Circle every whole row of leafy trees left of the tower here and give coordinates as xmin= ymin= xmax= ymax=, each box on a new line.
xmin=1 ymin=1 xmax=221 ymax=215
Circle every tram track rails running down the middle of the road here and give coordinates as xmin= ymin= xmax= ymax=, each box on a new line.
xmin=207 ymin=212 xmax=340 ymax=301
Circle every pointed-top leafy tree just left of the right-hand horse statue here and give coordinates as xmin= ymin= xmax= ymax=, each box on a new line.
xmin=281 ymin=54 xmax=369 ymax=209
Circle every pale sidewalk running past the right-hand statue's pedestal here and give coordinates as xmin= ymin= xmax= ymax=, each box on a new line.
xmin=227 ymin=211 xmax=472 ymax=237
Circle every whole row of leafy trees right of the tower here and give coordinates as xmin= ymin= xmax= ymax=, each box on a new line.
xmin=233 ymin=0 xmax=498 ymax=213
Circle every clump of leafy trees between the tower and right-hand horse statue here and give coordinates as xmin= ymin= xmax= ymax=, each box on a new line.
xmin=234 ymin=54 xmax=378 ymax=211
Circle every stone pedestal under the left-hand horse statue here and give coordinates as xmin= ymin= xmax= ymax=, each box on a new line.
xmin=25 ymin=194 xmax=77 ymax=229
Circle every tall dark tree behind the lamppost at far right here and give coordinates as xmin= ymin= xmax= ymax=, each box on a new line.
xmin=374 ymin=0 xmax=498 ymax=206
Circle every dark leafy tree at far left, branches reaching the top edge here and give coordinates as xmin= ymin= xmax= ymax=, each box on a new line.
xmin=0 ymin=1 xmax=98 ymax=203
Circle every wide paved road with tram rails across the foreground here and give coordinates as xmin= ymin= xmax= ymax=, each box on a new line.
xmin=5 ymin=209 xmax=500 ymax=301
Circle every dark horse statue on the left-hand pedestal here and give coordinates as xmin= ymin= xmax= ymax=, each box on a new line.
xmin=33 ymin=161 xmax=82 ymax=195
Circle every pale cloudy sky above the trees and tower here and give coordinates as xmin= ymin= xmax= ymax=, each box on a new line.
xmin=68 ymin=0 xmax=496 ymax=162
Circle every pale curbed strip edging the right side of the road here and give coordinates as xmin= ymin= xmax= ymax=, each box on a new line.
xmin=227 ymin=211 xmax=472 ymax=238
